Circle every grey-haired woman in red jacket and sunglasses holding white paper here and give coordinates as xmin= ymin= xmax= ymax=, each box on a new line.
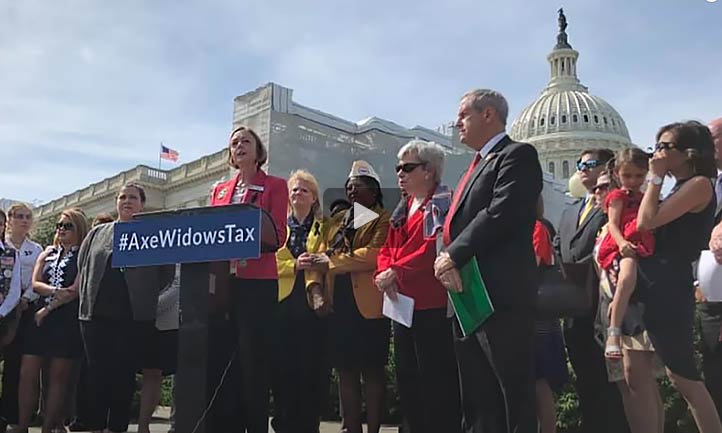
xmin=375 ymin=140 xmax=461 ymax=433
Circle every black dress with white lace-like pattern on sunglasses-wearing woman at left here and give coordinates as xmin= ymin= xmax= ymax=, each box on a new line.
xmin=23 ymin=247 xmax=83 ymax=359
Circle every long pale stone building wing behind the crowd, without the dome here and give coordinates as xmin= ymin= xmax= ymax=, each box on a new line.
xmin=36 ymin=83 xmax=565 ymax=226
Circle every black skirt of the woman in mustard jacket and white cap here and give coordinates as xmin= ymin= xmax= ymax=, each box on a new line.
xmin=329 ymin=274 xmax=391 ymax=369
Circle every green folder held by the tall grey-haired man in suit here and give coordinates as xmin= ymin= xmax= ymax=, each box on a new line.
xmin=448 ymin=257 xmax=494 ymax=337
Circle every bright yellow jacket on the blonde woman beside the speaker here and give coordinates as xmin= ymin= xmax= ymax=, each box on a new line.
xmin=276 ymin=217 xmax=328 ymax=306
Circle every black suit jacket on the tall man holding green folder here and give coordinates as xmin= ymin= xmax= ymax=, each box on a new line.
xmin=446 ymin=136 xmax=542 ymax=310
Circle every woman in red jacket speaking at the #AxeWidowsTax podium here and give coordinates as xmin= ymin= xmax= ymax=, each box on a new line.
xmin=211 ymin=126 xmax=288 ymax=433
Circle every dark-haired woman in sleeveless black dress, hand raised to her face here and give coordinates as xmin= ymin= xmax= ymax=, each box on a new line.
xmin=622 ymin=122 xmax=722 ymax=433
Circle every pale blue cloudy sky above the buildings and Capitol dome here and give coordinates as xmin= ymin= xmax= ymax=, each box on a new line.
xmin=0 ymin=0 xmax=722 ymax=201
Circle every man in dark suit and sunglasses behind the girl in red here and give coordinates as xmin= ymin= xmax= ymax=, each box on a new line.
xmin=554 ymin=149 xmax=629 ymax=433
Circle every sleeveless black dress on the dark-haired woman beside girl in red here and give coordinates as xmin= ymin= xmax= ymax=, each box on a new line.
xmin=637 ymin=180 xmax=716 ymax=380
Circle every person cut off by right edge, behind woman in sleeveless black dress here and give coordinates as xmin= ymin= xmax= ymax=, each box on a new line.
xmin=697 ymin=117 xmax=722 ymax=414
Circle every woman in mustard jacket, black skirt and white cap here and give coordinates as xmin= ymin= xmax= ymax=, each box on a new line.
xmin=313 ymin=161 xmax=391 ymax=433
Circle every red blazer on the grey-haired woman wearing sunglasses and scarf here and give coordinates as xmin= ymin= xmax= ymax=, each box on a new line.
xmin=374 ymin=199 xmax=448 ymax=310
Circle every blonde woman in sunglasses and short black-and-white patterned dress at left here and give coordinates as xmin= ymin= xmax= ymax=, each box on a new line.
xmin=16 ymin=209 xmax=88 ymax=433
